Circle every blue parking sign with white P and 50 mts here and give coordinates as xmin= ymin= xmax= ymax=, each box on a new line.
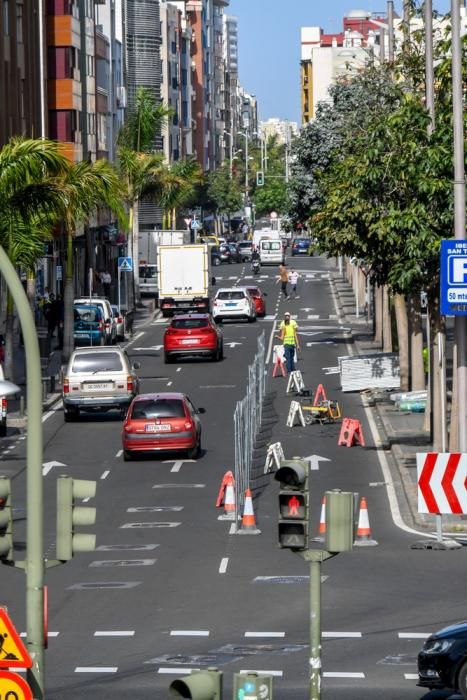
xmin=440 ymin=239 xmax=467 ymax=316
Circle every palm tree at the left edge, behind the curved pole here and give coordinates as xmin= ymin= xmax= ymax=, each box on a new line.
xmin=0 ymin=138 xmax=67 ymax=378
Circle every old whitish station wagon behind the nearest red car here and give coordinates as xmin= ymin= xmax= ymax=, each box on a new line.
xmin=62 ymin=346 xmax=140 ymax=422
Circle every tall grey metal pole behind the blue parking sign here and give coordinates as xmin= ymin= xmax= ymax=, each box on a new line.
xmin=451 ymin=0 xmax=467 ymax=452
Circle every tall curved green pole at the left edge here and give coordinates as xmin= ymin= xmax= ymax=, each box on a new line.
xmin=0 ymin=246 xmax=45 ymax=700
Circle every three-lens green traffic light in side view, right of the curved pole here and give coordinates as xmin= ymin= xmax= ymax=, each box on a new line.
xmin=57 ymin=476 xmax=96 ymax=561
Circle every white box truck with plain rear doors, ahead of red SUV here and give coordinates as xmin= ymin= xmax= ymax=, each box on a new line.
xmin=157 ymin=244 xmax=211 ymax=317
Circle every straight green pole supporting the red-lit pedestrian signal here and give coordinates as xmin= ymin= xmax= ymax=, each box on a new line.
xmin=300 ymin=549 xmax=336 ymax=700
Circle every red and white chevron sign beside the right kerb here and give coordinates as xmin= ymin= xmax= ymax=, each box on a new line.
xmin=417 ymin=452 xmax=467 ymax=515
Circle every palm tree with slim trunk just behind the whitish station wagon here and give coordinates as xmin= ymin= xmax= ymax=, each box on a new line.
xmin=58 ymin=160 xmax=126 ymax=359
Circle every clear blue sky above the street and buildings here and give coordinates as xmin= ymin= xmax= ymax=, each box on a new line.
xmin=230 ymin=0 xmax=450 ymax=124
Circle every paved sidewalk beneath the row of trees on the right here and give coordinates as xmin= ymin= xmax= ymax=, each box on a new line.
xmin=331 ymin=272 xmax=467 ymax=533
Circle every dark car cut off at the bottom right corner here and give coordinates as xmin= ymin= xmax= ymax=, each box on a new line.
xmin=417 ymin=622 xmax=467 ymax=700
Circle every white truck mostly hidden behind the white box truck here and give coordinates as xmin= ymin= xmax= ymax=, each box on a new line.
xmin=138 ymin=231 xmax=190 ymax=297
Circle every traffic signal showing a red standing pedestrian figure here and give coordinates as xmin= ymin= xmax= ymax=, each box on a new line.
xmin=274 ymin=457 xmax=308 ymax=550
